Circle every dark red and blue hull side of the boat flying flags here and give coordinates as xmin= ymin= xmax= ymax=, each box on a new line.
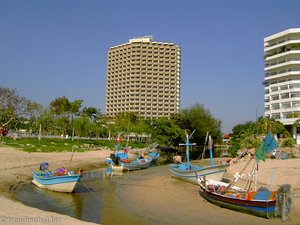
xmin=199 ymin=178 xmax=276 ymax=218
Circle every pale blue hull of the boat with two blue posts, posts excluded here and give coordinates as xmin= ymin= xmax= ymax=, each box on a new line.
xmin=169 ymin=164 xmax=229 ymax=185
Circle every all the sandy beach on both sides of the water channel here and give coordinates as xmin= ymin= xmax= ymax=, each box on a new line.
xmin=0 ymin=146 xmax=300 ymax=225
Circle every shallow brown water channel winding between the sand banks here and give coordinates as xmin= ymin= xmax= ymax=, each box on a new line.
xmin=14 ymin=168 xmax=129 ymax=223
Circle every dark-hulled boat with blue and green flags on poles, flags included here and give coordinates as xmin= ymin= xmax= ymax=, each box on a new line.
xmin=197 ymin=130 xmax=292 ymax=220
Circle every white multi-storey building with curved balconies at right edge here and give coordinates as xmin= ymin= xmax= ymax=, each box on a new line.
xmin=264 ymin=28 xmax=300 ymax=138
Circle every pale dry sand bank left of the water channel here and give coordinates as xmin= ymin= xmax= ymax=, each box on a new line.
xmin=0 ymin=146 xmax=110 ymax=225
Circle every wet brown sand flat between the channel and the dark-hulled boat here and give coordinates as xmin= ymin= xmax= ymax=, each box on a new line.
xmin=114 ymin=163 xmax=300 ymax=225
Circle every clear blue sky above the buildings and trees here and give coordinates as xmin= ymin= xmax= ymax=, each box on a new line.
xmin=0 ymin=0 xmax=300 ymax=132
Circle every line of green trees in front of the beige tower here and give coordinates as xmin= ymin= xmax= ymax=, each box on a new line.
xmin=0 ymin=87 xmax=222 ymax=147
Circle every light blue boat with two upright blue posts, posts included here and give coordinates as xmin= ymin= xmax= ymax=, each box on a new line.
xmin=169 ymin=133 xmax=229 ymax=184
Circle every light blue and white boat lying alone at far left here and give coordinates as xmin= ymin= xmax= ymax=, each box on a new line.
xmin=32 ymin=163 xmax=82 ymax=192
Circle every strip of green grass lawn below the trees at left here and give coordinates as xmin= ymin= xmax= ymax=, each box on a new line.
xmin=0 ymin=137 xmax=147 ymax=152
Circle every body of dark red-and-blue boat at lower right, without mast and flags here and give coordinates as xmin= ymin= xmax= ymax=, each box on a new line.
xmin=198 ymin=177 xmax=291 ymax=218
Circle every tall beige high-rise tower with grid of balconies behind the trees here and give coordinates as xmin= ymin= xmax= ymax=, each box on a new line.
xmin=106 ymin=36 xmax=181 ymax=119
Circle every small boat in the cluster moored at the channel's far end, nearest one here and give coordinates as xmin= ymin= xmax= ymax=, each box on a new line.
xmin=110 ymin=158 xmax=152 ymax=171
